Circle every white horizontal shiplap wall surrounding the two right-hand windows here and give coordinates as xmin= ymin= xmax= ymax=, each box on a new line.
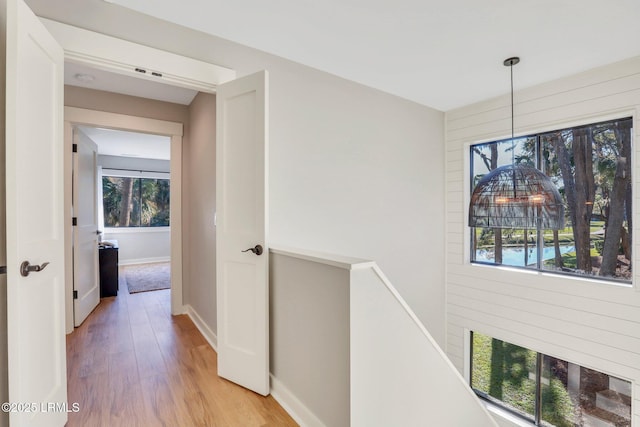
xmin=445 ymin=57 xmax=640 ymax=426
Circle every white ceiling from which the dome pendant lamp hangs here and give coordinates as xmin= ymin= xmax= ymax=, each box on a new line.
xmin=26 ymin=0 xmax=640 ymax=111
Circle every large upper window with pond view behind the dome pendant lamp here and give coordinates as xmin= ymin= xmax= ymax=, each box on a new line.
xmin=470 ymin=118 xmax=633 ymax=282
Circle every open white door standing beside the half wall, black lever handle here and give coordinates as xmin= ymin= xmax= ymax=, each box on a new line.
xmin=216 ymin=71 xmax=270 ymax=396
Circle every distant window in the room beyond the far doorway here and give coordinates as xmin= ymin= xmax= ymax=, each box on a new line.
xmin=102 ymin=176 xmax=170 ymax=227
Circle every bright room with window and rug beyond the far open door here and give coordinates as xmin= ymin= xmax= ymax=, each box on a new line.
xmin=82 ymin=126 xmax=171 ymax=286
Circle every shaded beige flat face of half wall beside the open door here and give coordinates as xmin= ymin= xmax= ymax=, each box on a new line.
xmin=269 ymin=252 xmax=350 ymax=427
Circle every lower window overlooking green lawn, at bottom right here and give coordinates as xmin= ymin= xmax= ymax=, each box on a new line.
xmin=471 ymin=332 xmax=632 ymax=427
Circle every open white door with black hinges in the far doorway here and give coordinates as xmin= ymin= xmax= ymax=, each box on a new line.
xmin=73 ymin=128 xmax=100 ymax=326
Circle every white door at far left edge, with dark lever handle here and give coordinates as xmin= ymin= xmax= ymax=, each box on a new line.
xmin=1 ymin=0 xmax=67 ymax=427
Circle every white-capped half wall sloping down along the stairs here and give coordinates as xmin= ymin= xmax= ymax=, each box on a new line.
xmin=270 ymin=247 xmax=497 ymax=427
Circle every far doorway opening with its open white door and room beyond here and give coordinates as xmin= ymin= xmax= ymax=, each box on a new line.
xmin=72 ymin=126 xmax=171 ymax=327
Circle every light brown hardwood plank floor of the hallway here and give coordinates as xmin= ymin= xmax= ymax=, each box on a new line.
xmin=67 ymin=281 xmax=297 ymax=427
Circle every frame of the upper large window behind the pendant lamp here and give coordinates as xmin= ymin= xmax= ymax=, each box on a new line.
xmin=465 ymin=114 xmax=636 ymax=287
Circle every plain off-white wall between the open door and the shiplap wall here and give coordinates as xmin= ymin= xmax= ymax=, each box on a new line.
xmin=33 ymin=0 xmax=445 ymax=343
